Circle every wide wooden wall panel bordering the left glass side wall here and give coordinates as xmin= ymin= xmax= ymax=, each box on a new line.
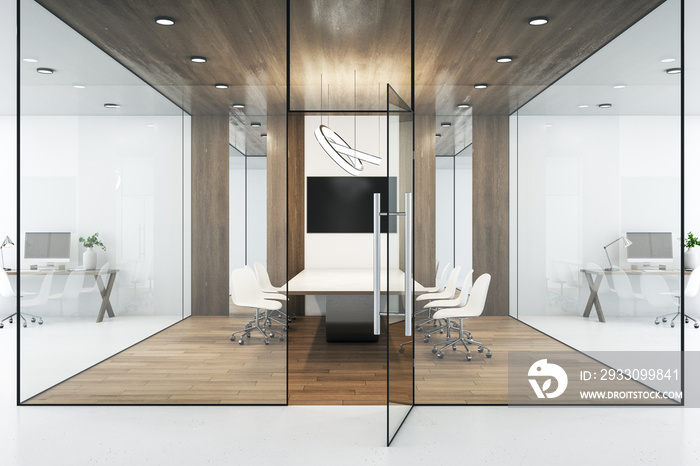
xmin=192 ymin=115 xmax=229 ymax=316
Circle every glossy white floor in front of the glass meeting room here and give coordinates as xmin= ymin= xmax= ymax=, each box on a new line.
xmin=0 ymin=322 xmax=700 ymax=466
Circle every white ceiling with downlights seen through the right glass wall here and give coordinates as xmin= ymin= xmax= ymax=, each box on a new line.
xmin=519 ymin=0 xmax=688 ymax=115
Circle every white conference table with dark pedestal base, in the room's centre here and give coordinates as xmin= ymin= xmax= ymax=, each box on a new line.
xmin=287 ymin=269 xmax=425 ymax=342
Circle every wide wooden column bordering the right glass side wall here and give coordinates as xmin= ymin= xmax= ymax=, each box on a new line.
xmin=470 ymin=115 xmax=509 ymax=316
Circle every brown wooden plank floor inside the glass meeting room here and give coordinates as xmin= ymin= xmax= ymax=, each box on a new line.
xmin=28 ymin=309 xmax=672 ymax=405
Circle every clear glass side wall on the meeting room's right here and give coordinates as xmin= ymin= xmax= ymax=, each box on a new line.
xmin=510 ymin=0 xmax=693 ymax=402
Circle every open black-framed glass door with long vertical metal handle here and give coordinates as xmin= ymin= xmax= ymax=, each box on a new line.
xmin=374 ymin=85 xmax=414 ymax=445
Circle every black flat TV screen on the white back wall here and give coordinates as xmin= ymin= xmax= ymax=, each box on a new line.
xmin=306 ymin=176 xmax=396 ymax=233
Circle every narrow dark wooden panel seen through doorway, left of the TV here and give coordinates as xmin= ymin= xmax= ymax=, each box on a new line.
xmin=287 ymin=113 xmax=306 ymax=316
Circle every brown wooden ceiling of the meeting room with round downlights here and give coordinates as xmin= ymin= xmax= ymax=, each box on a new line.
xmin=37 ymin=0 xmax=663 ymax=154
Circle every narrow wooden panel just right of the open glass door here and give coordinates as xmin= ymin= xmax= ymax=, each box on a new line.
xmin=413 ymin=115 xmax=435 ymax=286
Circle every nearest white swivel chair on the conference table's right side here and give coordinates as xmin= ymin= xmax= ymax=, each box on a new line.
xmin=432 ymin=273 xmax=492 ymax=361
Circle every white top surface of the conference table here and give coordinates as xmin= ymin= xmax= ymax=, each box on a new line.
xmin=287 ymin=269 xmax=423 ymax=295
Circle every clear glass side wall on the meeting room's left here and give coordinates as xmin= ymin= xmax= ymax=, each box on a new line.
xmin=16 ymin=1 xmax=191 ymax=404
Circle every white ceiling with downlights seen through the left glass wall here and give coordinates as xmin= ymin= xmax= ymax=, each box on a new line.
xmin=10 ymin=0 xmax=182 ymax=115
